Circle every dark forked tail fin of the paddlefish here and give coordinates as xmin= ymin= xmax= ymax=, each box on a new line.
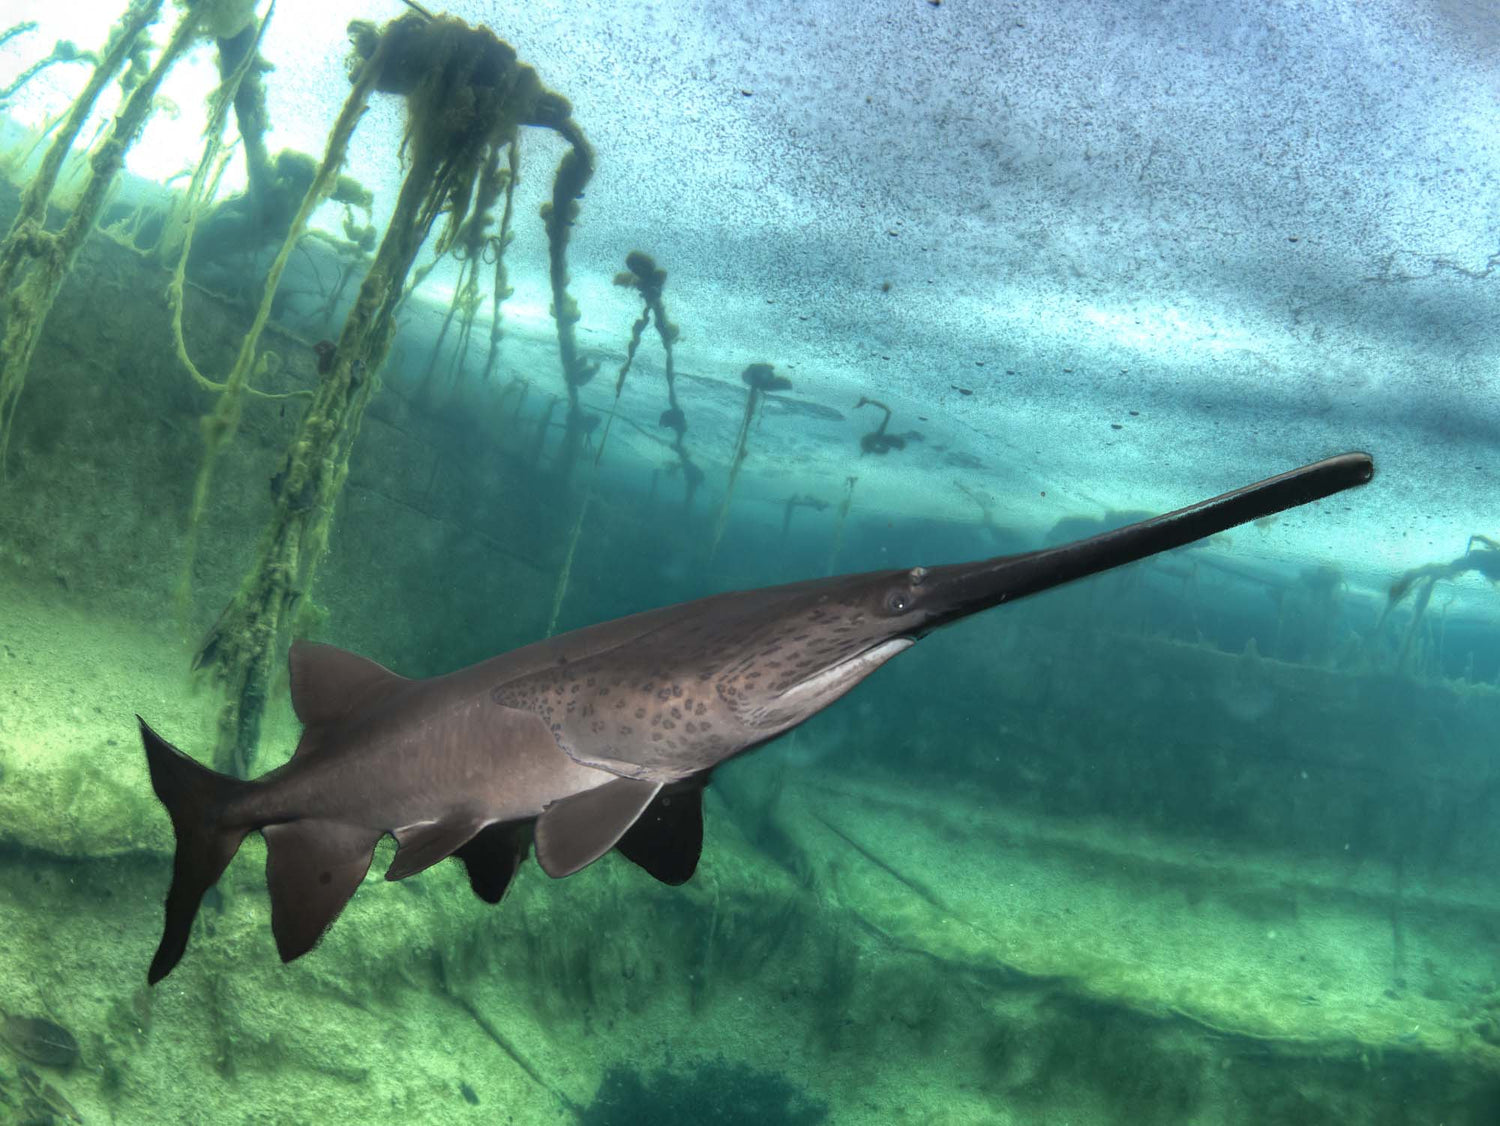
xmin=135 ymin=715 xmax=252 ymax=985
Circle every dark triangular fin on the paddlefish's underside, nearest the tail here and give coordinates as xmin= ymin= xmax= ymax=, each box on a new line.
xmin=261 ymin=819 xmax=381 ymax=961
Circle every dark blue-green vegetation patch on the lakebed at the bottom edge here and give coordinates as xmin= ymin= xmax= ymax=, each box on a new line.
xmin=578 ymin=1059 xmax=828 ymax=1126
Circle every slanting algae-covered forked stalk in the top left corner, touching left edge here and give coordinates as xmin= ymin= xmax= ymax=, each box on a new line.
xmin=0 ymin=0 xmax=200 ymax=475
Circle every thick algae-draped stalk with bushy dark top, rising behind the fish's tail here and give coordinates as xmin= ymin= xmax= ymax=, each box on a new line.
xmin=194 ymin=12 xmax=582 ymax=777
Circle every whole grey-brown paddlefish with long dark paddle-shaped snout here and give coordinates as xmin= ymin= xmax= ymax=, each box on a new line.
xmin=141 ymin=454 xmax=1373 ymax=982
